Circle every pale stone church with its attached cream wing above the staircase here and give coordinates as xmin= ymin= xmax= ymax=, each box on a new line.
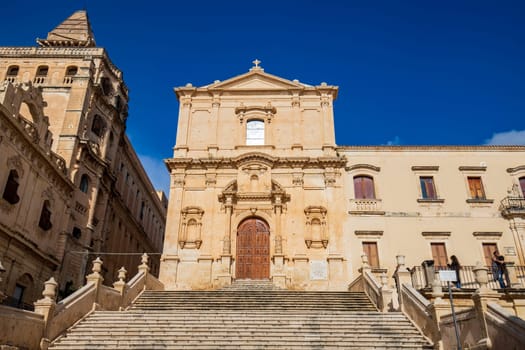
xmin=160 ymin=60 xmax=525 ymax=290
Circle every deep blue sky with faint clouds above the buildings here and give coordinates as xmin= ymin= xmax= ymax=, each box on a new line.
xmin=0 ymin=0 xmax=525 ymax=194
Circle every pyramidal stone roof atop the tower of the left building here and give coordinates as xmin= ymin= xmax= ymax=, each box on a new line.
xmin=36 ymin=10 xmax=96 ymax=47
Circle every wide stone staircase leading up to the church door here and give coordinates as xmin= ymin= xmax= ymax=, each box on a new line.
xmin=50 ymin=281 xmax=433 ymax=349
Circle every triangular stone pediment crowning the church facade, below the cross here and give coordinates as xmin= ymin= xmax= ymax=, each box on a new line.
xmin=205 ymin=68 xmax=309 ymax=90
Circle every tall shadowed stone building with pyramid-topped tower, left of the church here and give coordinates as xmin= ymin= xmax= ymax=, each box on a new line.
xmin=0 ymin=11 xmax=166 ymax=304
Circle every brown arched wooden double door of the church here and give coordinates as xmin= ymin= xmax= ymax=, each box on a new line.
xmin=236 ymin=218 xmax=270 ymax=279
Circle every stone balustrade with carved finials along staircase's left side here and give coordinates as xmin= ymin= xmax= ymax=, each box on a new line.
xmin=0 ymin=254 xmax=164 ymax=350
